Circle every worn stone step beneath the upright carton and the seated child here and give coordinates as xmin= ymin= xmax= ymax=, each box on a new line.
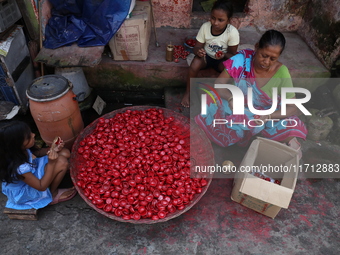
xmin=84 ymin=28 xmax=330 ymax=96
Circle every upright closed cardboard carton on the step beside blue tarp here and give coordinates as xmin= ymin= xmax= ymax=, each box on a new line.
xmin=109 ymin=1 xmax=151 ymax=60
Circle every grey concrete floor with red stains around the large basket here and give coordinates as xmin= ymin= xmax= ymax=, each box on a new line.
xmin=0 ymin=26 xmax=340 ymax=255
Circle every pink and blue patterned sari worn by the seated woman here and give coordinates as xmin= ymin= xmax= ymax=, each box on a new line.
xmin=195 ymin=50 xmax=307 ymax=147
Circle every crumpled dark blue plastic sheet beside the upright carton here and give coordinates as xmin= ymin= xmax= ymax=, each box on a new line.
xmin=44 ymin=0 xmax=131 ymax=49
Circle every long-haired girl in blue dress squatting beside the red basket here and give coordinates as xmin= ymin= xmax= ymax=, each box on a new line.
xmin=0 ymin=120 xmax=76 ymax=210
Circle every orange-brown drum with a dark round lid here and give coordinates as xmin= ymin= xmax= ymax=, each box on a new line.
xmin=26 ymin=75 xmax=84 ymax=149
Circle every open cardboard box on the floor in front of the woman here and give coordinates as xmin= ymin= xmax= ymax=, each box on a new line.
xmin=231 ymin=138 xmax=299 ymax=218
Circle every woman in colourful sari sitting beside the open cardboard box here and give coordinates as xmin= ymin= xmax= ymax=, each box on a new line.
xmin=195 ymin=30 xmax=307 ymax=147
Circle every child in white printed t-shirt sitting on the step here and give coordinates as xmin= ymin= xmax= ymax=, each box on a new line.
xmin=181 ymin=0 xmax=240 ymax=107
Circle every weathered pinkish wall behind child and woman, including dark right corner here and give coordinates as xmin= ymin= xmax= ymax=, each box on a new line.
xmin=151 ymin=0 xmax=340 ymax=69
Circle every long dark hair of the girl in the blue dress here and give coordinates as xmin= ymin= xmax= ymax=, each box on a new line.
xmin=0 ymin=120 xmax=31 ymax=183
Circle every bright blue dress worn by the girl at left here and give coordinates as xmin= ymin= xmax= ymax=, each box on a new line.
xmin=2 ymin=149 xmax=52 ymax=210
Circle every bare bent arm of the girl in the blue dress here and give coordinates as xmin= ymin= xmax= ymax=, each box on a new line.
xmin=22 ymin=150 xmax=58 ymax=191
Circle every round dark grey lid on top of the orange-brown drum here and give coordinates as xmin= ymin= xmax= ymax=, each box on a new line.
xmin=26 ymin=75 xmax=72 ymax=102
